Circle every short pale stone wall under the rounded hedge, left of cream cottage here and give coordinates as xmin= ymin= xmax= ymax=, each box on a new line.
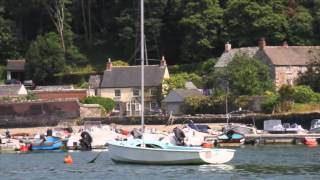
xmin=80 ymin=104 xmax=106 ymax=118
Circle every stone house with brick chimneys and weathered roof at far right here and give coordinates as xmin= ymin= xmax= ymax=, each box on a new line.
xmin=215 ymin=38 xmax=320 ymax=88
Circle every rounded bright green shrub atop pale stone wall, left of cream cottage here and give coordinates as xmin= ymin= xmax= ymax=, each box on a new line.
xmin=82 ymin=96 xmax=115 ymax=113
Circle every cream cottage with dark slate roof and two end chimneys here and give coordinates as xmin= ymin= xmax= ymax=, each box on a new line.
xmin=89 ymin=57 xmax=169 ymax=116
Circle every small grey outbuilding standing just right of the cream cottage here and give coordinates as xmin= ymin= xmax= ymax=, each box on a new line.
xmin=162 ymin=89 xmax=202 ymax=115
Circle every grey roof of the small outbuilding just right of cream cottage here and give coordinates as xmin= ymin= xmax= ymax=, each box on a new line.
xmin=162 ymin=89 xmax=203 ymax=103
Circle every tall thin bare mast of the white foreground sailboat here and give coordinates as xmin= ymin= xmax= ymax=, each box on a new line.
xmin=140 ymin=0 xmax=144 ymax=132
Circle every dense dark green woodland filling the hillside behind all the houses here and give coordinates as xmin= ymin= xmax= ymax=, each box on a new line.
xmin=0 ymin=0 xmax=320 ymax=70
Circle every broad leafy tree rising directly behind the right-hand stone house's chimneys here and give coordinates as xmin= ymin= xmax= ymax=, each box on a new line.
xmin=224 ymin=0 xmax=288 ymax=46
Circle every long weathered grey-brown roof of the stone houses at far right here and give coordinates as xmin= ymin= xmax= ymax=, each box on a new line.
xmin=215 ymin=46 xmax=320 ymax=68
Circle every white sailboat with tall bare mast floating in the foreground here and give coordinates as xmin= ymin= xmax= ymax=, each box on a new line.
xmin=109 ymin=0 xmax=235 ymax=164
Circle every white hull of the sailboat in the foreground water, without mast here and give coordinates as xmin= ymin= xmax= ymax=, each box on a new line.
xmin=109 ymin=142 xmax=235 ymax=165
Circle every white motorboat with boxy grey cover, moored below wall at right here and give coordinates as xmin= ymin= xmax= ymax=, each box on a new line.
xmin=263 ymin=119 xmax=306 ymax=133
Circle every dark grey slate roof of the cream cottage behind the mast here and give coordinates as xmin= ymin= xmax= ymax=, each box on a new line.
xmin=100 ymin=65 xmax=166 ymax=88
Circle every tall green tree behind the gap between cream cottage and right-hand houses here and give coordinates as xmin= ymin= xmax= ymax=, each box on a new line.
xmin=180 ymin=0 xmax=223 ymax=63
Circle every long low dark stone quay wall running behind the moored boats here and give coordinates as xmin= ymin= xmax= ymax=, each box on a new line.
xmin=83 ymin=112 xmax=320 ymax=129
